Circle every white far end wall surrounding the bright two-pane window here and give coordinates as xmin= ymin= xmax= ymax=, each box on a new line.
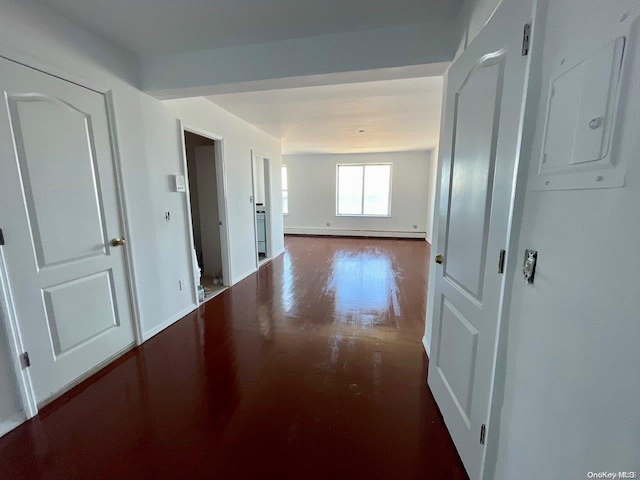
xmin=282 ymin=151 xmax=431 ymax=238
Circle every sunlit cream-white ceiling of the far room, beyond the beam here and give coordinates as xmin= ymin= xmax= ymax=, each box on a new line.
xmin=207 ymin=77 xmax=442 ymax=154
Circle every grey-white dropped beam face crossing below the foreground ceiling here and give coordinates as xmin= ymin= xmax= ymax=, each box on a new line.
xmin=142 ymin=23 xmax=460 ymax=99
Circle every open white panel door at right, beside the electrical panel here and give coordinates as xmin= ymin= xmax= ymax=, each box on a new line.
xmin=429 ymin=0 xmax=533 ymax=479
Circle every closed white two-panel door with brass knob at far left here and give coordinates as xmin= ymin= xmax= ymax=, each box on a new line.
xmin=0 ymin=59 xmax=134 ymax=403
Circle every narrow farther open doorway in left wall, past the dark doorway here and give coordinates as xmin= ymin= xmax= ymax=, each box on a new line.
xmin=251 ymin=153 xmax=272 ymax=268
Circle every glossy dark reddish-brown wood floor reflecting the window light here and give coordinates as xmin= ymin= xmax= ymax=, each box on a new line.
xmin=0 ymin=237 xmax=467 ymax=480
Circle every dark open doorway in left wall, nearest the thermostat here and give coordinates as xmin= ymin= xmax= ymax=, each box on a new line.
xmin=184 ymin=129 xmax=229 ymax=303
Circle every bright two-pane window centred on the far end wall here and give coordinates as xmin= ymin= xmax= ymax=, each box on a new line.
xmin=336 ymin=163 xmax=391 ymax=217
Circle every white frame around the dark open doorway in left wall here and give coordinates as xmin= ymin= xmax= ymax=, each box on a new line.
xmin=178 ymin=120 xmax=231 ymax=305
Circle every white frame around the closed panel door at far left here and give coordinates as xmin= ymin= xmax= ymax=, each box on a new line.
xmin=0 ymin=54 xmax=144 ymax=426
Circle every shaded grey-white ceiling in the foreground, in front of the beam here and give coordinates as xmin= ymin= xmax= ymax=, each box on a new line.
xmin=40 ymin=0 xmax=460 ymax=55
